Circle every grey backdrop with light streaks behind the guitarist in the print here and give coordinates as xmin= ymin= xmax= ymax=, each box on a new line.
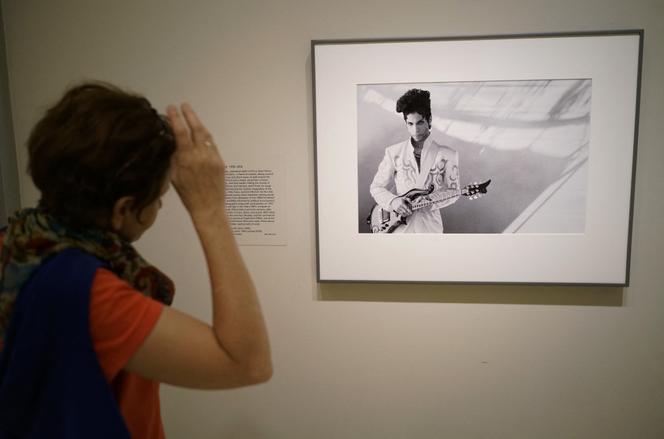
xmin=358 ymin=79 xmax=592 ymax=233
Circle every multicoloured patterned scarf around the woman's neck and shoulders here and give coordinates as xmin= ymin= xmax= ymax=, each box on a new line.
xmin=0 ymin=209 xmax=175 ymax=352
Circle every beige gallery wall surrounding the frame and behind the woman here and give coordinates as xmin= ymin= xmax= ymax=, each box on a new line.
xmin=2 ymin=0 xmax=664 ymax=439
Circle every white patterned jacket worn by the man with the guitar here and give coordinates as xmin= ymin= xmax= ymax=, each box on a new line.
xmin=369 ymin=136 xmax=459 ymax=233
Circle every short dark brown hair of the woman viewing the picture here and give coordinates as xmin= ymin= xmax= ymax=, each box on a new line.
xmin=28 ymin=82 xmax=175 ymax=227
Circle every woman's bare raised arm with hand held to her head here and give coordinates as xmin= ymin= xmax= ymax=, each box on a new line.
xmin=125 ymin=104 xmax=272 ymax=389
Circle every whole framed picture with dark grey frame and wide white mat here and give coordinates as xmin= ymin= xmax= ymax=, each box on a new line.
xmin=312 ymin=30 xmax=643 ymax=285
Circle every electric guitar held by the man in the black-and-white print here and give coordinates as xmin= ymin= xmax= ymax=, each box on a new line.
xmin=367 ymin=180 xmax=491 ymax=233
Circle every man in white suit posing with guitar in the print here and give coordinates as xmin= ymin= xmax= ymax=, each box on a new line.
xmin=369 ymin=89 xmax=459 ymax=233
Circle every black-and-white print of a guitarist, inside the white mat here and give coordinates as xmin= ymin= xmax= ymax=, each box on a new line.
xmin=357 ymin=78 xmax=592 ymax=233
